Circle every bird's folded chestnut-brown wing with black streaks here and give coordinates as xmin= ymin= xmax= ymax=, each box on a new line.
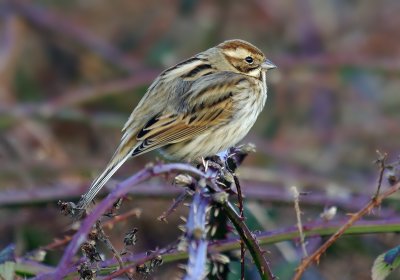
xmin=126 ymin=72 xmax=246 ymax=155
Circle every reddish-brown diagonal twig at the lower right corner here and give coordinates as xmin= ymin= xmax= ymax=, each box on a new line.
xmin=293 ymin=180 xmax=400 ymax=280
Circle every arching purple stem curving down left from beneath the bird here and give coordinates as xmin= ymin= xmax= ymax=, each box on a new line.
xmin=37 ymin=163 xmax=205 ymax=279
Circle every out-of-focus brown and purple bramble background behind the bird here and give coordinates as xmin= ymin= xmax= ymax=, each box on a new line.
xmin=0 ymin=0 xmax=400 ymax=279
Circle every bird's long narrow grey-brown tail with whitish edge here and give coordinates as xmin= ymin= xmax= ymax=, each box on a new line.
xmin=77 ymin=150 xmax=130 ymax=211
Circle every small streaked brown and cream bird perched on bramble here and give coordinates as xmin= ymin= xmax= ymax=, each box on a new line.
xmin=77 ymin=39 xmax=276 ymax=210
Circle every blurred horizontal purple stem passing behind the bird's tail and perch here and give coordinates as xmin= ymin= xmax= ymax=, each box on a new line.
xmin=0 ymin=181 xmax=394 ymax=216
